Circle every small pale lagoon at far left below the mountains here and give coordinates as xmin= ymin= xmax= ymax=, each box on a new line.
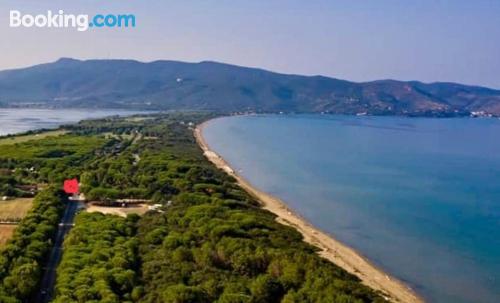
xmin=0 ymin=108 xmax=150 ymax=136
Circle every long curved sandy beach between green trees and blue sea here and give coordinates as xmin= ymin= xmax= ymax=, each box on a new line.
xmin=194 ymin=118 xmax=424 ymax=303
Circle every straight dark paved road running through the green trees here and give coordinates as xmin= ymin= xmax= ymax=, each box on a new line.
xmin=32 ymin=201 xmax=80 ymax=303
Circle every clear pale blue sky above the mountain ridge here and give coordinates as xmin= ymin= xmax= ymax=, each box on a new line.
xmin=0 ymin=0 xmax=500 ymax=89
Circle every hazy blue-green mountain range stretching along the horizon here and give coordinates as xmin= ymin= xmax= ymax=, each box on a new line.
xmin=0 ymin=58 xmax=500 ymax=116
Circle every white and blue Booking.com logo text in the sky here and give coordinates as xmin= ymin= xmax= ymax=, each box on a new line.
xmin=10 ymin=10 xmax=135 ymax=32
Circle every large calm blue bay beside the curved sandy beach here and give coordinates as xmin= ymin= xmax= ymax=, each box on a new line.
xmin=204 ymin=115 xmax=500 ymax=303
